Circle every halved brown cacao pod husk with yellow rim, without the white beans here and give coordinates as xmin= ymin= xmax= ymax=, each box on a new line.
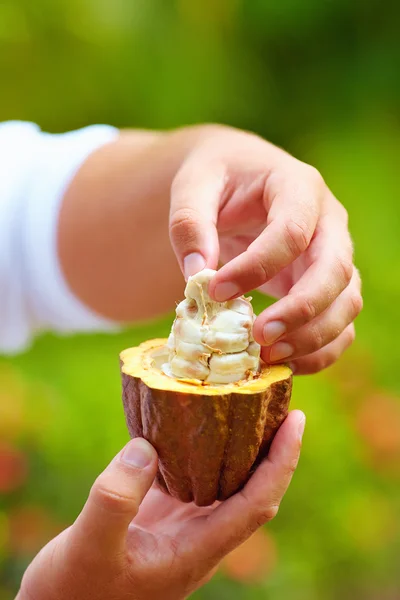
xmin=120 ymin=339 xmax=292 ymax=506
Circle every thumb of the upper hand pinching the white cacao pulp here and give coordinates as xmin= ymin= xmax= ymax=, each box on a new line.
xmin=169 ymin=162 xmax=225 ymax=280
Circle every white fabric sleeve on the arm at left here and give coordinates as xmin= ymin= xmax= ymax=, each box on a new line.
xmin=0 ymin=121 xmax=118 ymax=353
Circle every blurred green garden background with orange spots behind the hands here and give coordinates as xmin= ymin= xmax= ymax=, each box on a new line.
xmin=0 ymin=0 xmax=400 ymax=600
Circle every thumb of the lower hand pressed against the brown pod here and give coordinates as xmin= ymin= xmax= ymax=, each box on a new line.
xmin=71 ymin=438 xmax=157 ymax=554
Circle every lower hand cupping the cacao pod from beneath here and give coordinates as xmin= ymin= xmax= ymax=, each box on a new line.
xmin=17 ymin=411 xmax=305 ymax=600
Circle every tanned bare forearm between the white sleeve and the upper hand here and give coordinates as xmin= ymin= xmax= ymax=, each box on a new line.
xmin=58 ymin=127 xmax=211 ymax=321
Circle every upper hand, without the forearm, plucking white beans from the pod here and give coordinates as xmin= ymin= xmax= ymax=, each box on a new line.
xmin=170 ymin=127 xmax=362 ymax=373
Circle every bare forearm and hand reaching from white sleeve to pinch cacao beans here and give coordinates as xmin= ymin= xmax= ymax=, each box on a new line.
xmin=58 ymin=125 xmax=362 ymax=374
